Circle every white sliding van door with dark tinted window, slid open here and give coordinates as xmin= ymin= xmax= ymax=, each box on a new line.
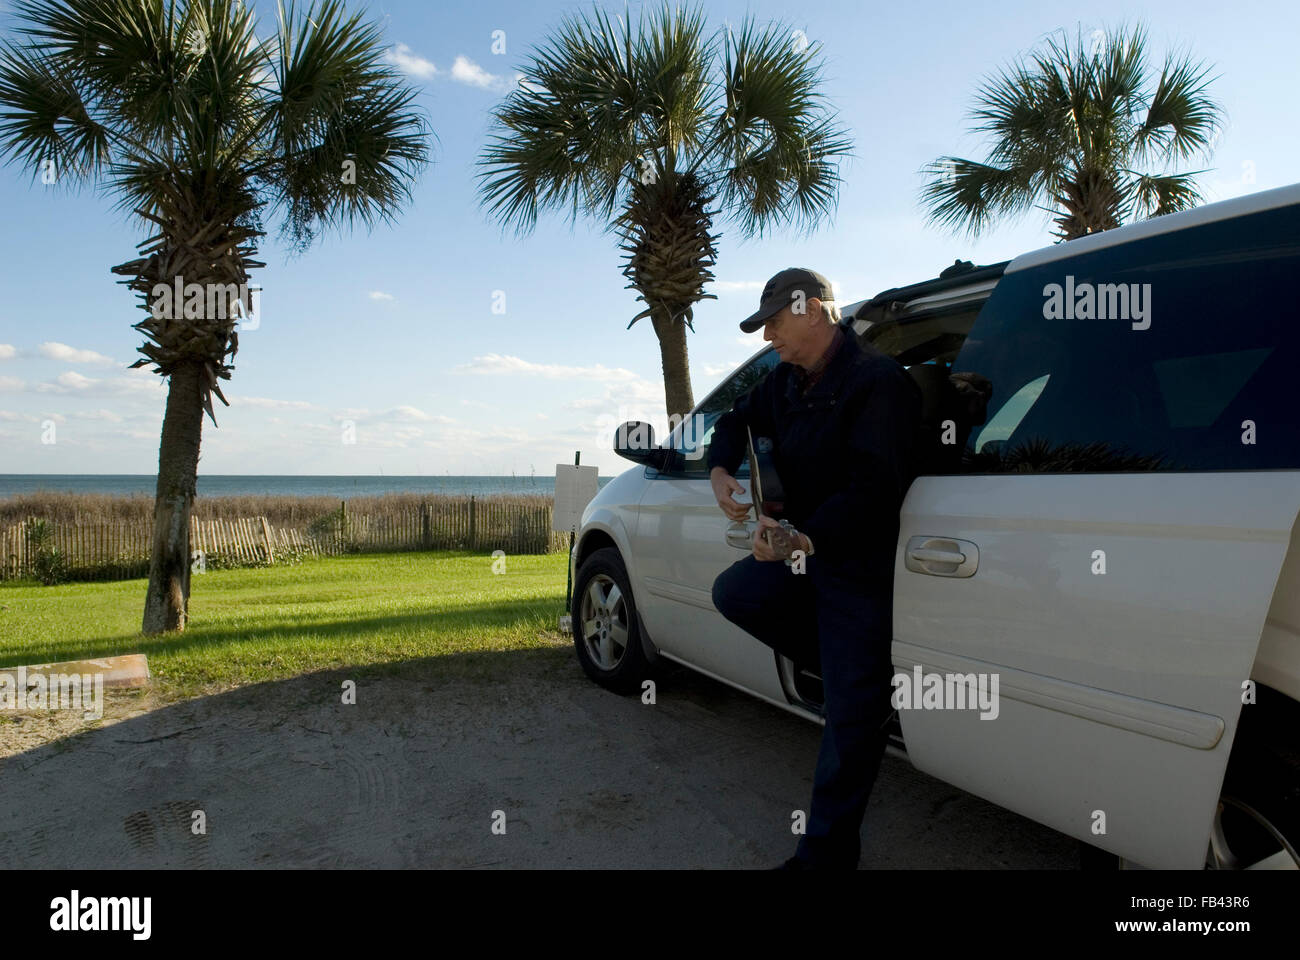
xmin=893 ymin=187 xmax=1300 ymax=868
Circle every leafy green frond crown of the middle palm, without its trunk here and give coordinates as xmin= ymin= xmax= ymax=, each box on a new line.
xmin=478 ymin=4 xmax=852 ymax=234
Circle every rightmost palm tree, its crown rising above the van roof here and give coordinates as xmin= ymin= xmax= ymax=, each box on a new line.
xmin=922 ymin=26 xmax=1223 ymax=239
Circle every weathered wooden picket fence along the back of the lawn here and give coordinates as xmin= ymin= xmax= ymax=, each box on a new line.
xmin=0 ymin=497 xmax=568 ymax=580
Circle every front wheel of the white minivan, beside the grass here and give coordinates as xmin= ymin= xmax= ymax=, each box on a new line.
xmin=572 ymin=546 xmax=658 ymax=695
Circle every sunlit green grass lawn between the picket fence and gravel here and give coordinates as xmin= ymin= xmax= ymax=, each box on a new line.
xmin=0 ymin=552 xmax=568 ymax=697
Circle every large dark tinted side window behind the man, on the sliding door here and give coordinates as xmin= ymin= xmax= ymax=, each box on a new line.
xmin=953 ymin=207 xmax=1300 ymax=473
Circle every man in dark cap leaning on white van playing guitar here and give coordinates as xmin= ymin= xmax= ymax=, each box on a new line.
xmin=709 ymin=268 xmax=920 ymax=869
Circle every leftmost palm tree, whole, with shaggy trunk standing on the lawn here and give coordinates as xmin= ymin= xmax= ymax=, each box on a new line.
xmin=0 ymin=0 xmax=428 ymax=633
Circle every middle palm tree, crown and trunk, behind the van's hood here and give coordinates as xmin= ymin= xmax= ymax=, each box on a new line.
xmin=478 ymin=4 xmax=850 ymax=418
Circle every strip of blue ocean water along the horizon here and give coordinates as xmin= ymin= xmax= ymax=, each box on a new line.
xmin=0 ymin=473 xmax=614 ymax=500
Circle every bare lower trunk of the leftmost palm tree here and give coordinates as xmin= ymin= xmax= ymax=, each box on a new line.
xmin=143 ymin=363 xmax=203 ymax=633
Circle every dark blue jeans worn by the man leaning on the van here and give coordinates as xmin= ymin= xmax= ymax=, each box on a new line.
xmin=714 ymin=554 xmax=893 ymax=869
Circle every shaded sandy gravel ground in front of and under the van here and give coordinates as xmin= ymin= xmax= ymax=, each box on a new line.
xmin=0 ymin=645 xmax=1078 ymax=869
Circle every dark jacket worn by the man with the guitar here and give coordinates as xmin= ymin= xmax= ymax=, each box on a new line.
xmin=709 ymin=328 xmax=920 ymax=588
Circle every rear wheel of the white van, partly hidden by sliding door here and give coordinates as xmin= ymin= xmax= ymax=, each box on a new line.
xmin=1079 ymin=687 xmax=1300 ymax=870
